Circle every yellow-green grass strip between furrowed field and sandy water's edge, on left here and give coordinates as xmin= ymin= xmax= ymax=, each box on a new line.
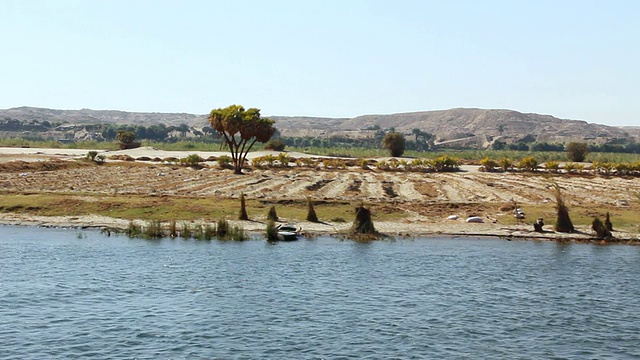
xmin=0 ymin=193 xmax=406 ymax=222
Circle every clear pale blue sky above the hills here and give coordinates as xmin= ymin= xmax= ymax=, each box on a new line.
xmin=0 ymin=0 xmax=640 ymax=126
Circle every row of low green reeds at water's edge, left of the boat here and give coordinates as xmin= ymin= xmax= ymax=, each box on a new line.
xmin=120 ymin=220 xmax=249 ymax=241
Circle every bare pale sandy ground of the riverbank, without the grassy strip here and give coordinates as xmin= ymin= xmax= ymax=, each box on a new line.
xmin=0 ymin=148 xmax=640 ymax=241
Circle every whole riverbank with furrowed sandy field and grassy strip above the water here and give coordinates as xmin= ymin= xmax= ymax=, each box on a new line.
xmin=0 ymin=148 xmax=640 ymax=242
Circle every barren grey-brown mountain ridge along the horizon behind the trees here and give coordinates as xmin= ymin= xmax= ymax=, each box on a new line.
xmin=0 ymin=107 xmax=640 ymax=142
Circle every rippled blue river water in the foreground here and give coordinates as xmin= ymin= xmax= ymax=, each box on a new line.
xmin=0 ymin=227 xmax=640 ymax=359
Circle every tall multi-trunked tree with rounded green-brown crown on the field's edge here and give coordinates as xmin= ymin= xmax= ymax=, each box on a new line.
xmin=209 ymin=105 xmax=276 ymax=174
